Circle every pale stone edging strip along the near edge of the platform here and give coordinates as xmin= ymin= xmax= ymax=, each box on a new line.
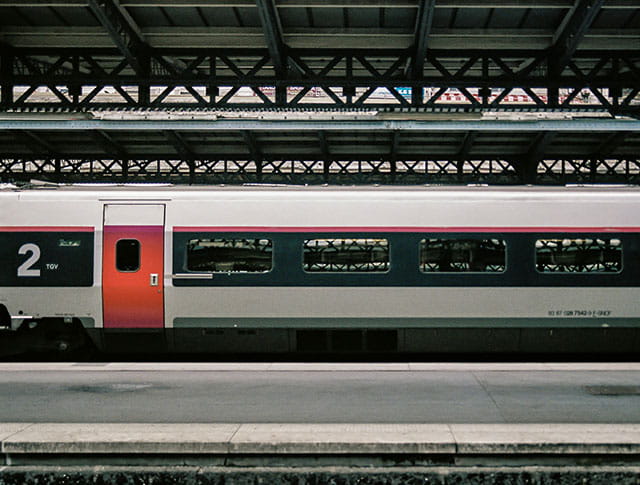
xmin=0 ymin=423 xmax=640 ymax=455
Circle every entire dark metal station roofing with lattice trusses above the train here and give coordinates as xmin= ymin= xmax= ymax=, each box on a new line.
xmin=0 ymin=0 xmax=640 ymax=183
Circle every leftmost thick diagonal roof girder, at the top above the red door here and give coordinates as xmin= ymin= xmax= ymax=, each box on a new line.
xmin=87 ymin=0 xmax=149 ymax=75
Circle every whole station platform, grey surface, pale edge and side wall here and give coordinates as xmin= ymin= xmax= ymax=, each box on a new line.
xmin=0 ymin=362 xmax=640 ymax=485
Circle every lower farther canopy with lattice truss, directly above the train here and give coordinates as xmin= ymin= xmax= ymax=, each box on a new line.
xmin=0 ymin=120 xmax=640 ymax=185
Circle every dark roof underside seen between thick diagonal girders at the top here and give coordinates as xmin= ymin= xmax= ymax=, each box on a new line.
xmin=0 ymin=0 xmax=640 ymax=53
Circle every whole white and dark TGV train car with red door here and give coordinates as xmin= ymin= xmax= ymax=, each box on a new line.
xmin=0 ymin=186 xmax=640 ymax=353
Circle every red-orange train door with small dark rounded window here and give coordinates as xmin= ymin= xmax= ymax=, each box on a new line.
xmin=102 ymin=225 xmax=164 ymax=328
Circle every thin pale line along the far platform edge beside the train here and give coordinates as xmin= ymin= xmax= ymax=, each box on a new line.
xmin=0 ymin=362 xmax=640 ymax=372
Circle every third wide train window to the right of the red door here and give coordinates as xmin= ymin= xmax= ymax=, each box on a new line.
xmin=420 ymin=238 xmax=507 ymax=273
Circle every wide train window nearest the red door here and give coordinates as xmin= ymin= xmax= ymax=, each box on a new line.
xmin=187 ymin=238 xmax=273 ymax=273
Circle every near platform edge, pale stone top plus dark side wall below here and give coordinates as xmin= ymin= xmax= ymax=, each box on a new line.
xmin=0 ymin=423 xmax=640 ymax=484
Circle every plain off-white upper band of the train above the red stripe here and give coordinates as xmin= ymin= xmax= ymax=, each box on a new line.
xmin=0 ymin=185 xmax=640 ymax=230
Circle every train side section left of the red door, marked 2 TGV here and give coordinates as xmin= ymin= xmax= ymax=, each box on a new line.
xmin=0 ymin=192 xmax=102 ymax=336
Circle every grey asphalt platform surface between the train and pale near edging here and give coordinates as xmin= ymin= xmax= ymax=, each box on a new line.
xmin=0 ymin=363 xmax=640 ymax=424
